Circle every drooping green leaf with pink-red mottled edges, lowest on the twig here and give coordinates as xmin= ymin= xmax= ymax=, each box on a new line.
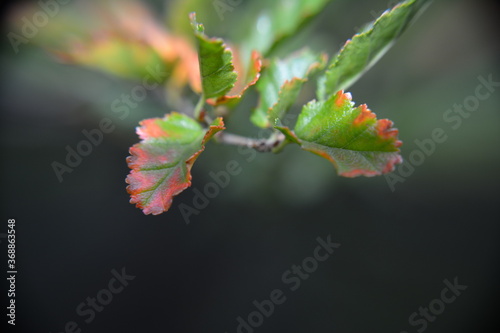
xmin=126 ymin=112 xmax=225 ymax=215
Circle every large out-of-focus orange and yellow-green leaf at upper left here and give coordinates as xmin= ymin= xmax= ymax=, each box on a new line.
xmin=7 ymin=0 xmax=201 ymax=92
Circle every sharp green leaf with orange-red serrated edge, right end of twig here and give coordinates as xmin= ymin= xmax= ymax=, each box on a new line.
xmin=276 ymin=91 xmax=402 ymax=177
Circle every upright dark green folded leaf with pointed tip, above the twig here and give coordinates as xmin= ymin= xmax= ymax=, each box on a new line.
xmin=191 ymin=13 xmax=238 ymax=99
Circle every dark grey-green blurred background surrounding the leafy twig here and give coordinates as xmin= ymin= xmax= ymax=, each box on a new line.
xmin=0 ymin=0 xmax=500 ymax=333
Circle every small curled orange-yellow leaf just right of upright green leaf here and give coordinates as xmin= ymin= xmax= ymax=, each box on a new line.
xmin=207 ymin=51 xmax=262 ymax=107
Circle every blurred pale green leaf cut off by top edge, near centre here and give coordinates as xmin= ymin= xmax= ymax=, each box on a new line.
xmin=237 ymin=0 xmax=331 ymax=61
